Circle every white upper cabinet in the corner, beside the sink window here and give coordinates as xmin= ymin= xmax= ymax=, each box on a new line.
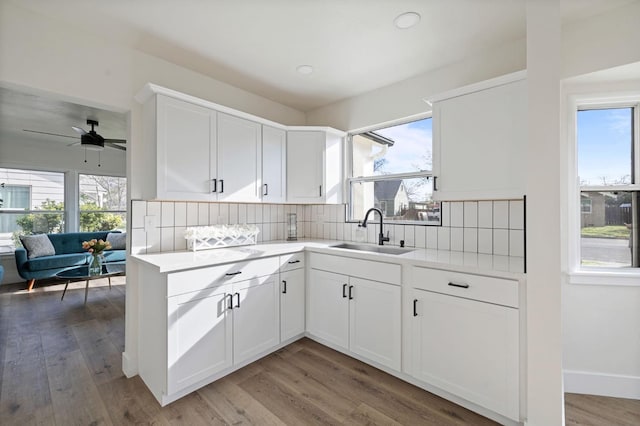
xmin=287 ymin=129 xmax=344 ymax=204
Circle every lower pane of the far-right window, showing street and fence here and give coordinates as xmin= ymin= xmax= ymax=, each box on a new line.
xmin=580 ymin=191 xmax=638 ymax=267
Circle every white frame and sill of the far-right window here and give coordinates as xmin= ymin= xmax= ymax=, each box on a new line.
xmin=564 ymin=91 xmax=640 ymax=286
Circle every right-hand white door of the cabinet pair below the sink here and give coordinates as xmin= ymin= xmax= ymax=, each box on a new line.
xmin=348 ymin=277 xmax=402 ymax=370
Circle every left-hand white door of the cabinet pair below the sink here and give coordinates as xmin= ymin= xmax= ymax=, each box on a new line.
xmin=307 ymin=269 xmax=349 ymax=349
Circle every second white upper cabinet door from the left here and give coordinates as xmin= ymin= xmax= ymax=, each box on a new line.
xmin=217 ymin=113 xmax=262 ymax=201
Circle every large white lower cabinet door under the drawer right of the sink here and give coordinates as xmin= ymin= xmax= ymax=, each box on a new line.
xmin=410 ymin=289 xmax=519 ymax=420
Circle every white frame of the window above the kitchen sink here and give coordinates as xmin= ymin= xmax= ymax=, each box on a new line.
xmin=344 ymin=115 xmax=442 ymax=226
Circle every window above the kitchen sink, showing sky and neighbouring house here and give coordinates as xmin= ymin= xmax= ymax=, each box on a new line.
xmin=347 ymin=118 xmax=440 ymax=225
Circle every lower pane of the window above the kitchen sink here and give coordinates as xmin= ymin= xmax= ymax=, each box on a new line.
xmin=351 ymin=178 xmax=440 ymax=225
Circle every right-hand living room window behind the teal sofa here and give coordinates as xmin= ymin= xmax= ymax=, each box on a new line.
xmin=78 ymin=174 xmax=127 ymax=231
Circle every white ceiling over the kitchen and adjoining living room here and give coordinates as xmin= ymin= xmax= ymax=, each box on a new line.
xmin=0 ymin=0 xmax=639 ymax=150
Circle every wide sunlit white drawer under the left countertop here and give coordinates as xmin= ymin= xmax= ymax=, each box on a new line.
xmin=167 ymin=257 xmax=279 ymax=297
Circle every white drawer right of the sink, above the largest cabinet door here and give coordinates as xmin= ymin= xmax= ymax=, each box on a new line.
xmin=411 ymin=267 xmax=518 ymax=308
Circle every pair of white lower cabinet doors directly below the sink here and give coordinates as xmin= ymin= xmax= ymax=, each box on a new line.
xmin=307 ymin=269 xmax=401 ymax=370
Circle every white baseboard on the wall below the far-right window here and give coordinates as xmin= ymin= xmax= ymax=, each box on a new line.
xmin=563 ymin=370 xmax=640 ymax=399
